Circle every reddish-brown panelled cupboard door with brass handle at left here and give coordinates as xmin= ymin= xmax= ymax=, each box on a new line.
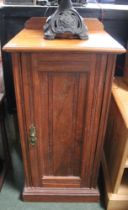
xmin=22 ymin=53 xmax=106 ymax=188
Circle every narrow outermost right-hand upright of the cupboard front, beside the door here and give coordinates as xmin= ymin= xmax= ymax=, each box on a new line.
xmin=92 ymin=55 xmax=116 ymax=186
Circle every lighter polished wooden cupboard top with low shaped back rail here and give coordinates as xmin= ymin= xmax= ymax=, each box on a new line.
xmin=3 ymin=18 xmax=125 ymax=54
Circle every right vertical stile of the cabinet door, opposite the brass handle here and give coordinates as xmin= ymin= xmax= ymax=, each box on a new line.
xmin=82 ymin=54 xmax=107 ymax=187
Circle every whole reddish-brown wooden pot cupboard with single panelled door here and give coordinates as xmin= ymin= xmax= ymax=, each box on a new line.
xmin=4 ymin=18 xmax=125 ymax=202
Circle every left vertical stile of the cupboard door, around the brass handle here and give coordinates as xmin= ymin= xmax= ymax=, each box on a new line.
xmin=22 ymin=53 xmax=39 ymax=187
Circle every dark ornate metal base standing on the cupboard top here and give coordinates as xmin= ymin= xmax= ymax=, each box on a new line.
xmin=44 ymin=0 xmax=88 ymax=40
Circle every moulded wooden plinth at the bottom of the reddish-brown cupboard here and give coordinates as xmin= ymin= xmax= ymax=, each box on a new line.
xmin=22 ymin=187 xmax=100 ymax=202
